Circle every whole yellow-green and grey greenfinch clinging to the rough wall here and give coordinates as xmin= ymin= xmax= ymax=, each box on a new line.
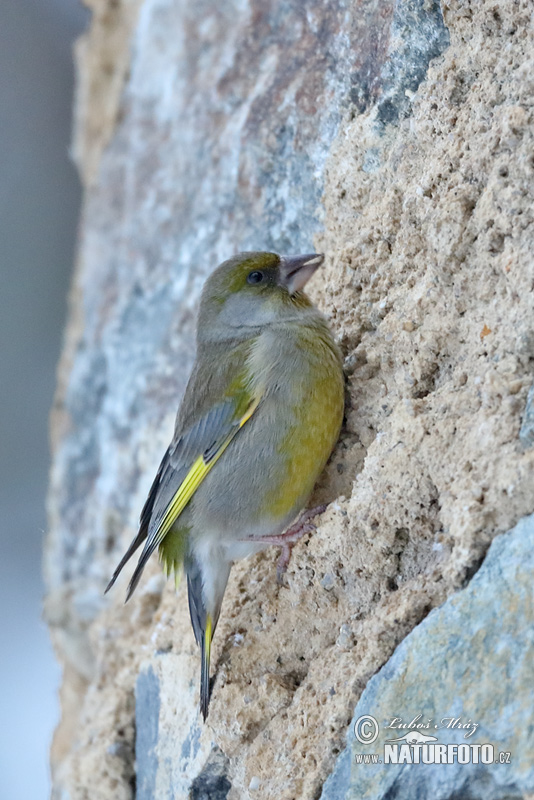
xmin=106 ymin=252 xmax=344 ymax=719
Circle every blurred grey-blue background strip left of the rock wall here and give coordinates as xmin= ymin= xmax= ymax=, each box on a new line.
xmin=0 ymin=0 xmax=88 ymax=800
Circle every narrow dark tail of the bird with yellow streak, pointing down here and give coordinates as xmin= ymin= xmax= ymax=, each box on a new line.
xmin=186 ymin=559 xmax=230 ymax=721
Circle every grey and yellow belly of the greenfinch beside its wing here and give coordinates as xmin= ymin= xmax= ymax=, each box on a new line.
xmin=192 ymin=354 xmax=343 ymax=548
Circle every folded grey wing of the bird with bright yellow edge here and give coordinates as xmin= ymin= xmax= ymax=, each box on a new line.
xmin=106 ymin=344 xmax=261 ymax=600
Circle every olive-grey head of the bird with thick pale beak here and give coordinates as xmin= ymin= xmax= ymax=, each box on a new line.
xmin=198 ymin=247 xmax=324 ymax=342
